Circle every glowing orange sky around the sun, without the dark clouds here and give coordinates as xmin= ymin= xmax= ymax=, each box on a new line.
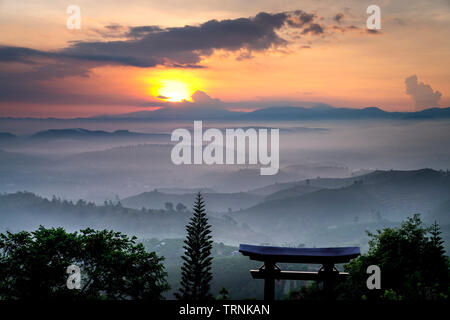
xmin=0 ymin=0 xmax=450 ymax=117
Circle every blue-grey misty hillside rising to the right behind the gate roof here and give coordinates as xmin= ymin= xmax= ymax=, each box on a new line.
xmin=232 ymin=169 xmax=450 ymax=239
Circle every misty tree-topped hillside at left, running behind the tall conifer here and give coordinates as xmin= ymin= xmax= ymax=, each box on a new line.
xmin=0 ymin=192 xmax=267 ymax=244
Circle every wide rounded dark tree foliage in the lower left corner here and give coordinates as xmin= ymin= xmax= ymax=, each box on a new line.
xmin=0 ymin=226 xmax=169 ymax=300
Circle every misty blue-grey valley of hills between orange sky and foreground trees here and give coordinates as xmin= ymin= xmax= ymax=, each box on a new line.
xmin=0 ymin=119 xmax=450 ymax=299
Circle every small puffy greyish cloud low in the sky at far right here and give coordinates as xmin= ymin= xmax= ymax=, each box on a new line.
xmin=405 ymin=75 xmax=442 ymax=109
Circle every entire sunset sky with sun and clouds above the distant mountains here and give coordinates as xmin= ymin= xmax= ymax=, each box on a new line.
xmin=0 ymin=0 xmax=450 ymax=118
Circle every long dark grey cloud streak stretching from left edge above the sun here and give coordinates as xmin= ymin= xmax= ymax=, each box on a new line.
xmin=0 ymin=11 xmax=323 ymax=67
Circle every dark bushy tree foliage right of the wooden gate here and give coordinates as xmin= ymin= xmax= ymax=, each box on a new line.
xmin=337 ymin=214 xmax=449 ymax=300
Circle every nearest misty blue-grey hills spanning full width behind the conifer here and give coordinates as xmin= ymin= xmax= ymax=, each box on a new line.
xmin=0 ymin=169 xmax=450 ymax=245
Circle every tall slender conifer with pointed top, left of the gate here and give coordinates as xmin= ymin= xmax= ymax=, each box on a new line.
xmin=175 ymin=192 xmax=212 ymax=300
